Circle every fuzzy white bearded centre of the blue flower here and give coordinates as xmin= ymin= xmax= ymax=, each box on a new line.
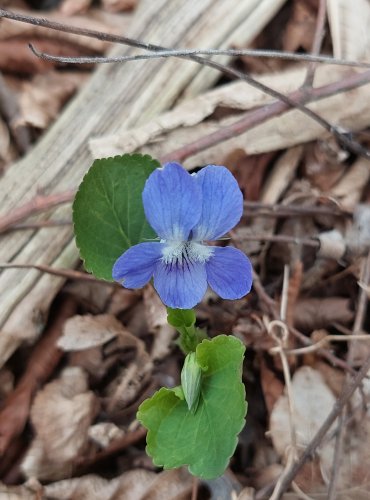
xmin=162 ymin=240 xmax=213 ymax=265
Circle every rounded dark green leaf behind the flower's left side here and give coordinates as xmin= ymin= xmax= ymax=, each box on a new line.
xmin=73 ymin=154 xmax=160 ymax=281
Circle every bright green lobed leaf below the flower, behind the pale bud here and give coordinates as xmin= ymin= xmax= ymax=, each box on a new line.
xmin=137 ymin=335 xmax=247 ymax=479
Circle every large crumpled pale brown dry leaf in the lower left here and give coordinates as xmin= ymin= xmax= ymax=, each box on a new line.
xmin=21 ymin=367 xmax=97 ymax=480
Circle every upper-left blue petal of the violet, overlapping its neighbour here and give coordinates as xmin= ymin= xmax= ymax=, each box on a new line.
xmin=143 ymin=163 xmax=202 ymax=241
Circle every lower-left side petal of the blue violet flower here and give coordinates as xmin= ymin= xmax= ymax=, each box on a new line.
xmin=112 ymin=242 xmax=164 ymax=288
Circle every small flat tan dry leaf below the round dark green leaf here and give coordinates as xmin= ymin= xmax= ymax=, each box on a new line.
xmin=58 ymin=314 xmax=125 ymax=351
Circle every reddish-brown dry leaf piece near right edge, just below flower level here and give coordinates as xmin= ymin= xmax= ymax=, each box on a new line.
xmin=294 ymin=297 xmax=354 ymax=331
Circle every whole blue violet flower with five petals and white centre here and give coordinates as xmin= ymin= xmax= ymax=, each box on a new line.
xmin=112 ymin=162 xmax=252 ymax=309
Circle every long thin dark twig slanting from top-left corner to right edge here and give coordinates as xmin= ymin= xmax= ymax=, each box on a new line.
xmin=0 ymin=9 xmax=370 ymax=160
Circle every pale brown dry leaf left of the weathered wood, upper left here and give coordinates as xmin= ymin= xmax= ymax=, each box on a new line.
xmin=19 ymin=71 xmax=88 ymax=129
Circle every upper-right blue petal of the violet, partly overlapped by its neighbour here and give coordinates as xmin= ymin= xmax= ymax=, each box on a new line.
xmin=192 ymin=165 xmax=243 ymax=241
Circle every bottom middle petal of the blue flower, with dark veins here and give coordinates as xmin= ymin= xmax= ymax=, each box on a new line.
xmin=154 ymin=261 xmax=207 ymax=309
